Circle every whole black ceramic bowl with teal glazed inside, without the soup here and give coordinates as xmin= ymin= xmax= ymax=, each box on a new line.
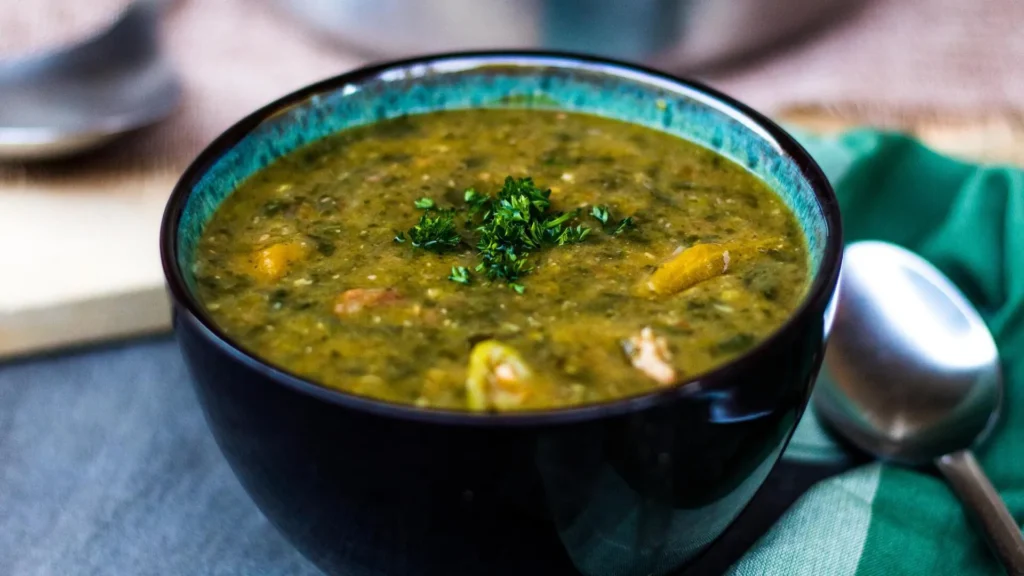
xmin=161 ymin=52 xmax=842 ymax=576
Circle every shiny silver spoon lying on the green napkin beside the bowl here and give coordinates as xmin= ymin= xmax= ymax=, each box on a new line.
xmin=815 ymin=242 xmax=1024 ymax=576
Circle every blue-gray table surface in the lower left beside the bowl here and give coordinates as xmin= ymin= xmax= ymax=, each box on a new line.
xmin=0 ymin=339 xmax=319 ymax=576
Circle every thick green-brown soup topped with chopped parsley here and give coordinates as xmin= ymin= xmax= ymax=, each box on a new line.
xmin=194 ymin=110 xmax=808 ymax=411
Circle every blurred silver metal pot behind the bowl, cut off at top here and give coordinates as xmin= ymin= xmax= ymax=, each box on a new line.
xmin=273 ymin=0 xmax=863 ymax=70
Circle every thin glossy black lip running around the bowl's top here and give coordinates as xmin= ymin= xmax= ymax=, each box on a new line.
xmin=160 ymin=49 xmax=843 ymax=426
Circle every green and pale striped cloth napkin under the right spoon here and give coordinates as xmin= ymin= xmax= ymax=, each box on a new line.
xmin=730 ymin=131 xmax=1024 ymax=576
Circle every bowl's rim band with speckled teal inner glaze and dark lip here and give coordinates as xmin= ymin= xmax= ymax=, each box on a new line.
xmin=161 ymin=51 xmax=843 ymax=423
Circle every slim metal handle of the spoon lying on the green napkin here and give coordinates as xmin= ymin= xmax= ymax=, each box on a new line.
xmin=935 ymin=450 xmax=1024 ymax=576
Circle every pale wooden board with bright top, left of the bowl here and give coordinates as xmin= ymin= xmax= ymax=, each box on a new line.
xmin=0 ymin=170 xmax=177 ymax=359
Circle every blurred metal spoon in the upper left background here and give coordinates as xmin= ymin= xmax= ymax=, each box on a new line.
xmin=0 ymin=0 xmax=181 ymax=161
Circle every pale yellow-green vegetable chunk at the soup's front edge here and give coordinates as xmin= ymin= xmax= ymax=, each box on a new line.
xmin=466 ymin=340 xmax=534 ymax=410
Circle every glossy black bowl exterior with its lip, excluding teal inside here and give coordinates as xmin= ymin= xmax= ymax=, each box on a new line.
xmin=161 ymin=52 xmax=842 ymax=576
